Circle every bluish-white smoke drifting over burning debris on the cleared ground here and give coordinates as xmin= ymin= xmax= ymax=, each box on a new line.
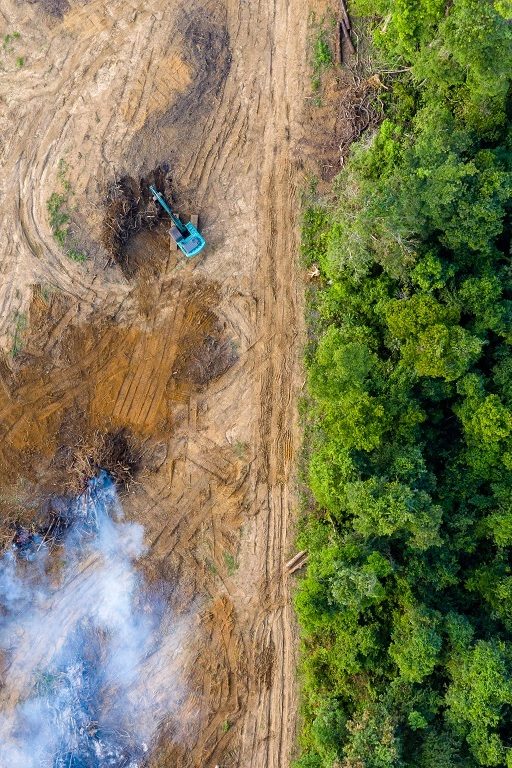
xmin=0 ymin=472 xmax=187 ymax=768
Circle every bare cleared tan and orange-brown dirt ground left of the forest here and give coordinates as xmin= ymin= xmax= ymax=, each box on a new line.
xmin=0 ymin=0 xmax=324 ymax=768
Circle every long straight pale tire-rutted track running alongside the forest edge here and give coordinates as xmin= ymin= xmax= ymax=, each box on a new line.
xmin=236 ymin=3 xmax=305 ymax=768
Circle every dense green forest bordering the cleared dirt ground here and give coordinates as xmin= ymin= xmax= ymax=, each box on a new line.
xmin=296 ymin=0 xmax=512 ymax=768
